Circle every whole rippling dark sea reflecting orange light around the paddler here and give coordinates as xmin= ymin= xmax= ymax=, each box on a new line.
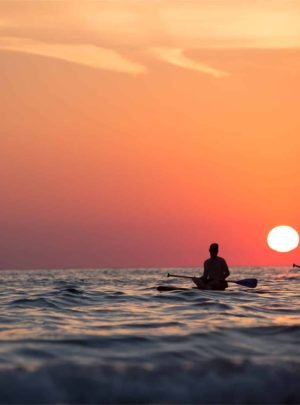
xmin=0 ymin=268 xmax=300 ymax=404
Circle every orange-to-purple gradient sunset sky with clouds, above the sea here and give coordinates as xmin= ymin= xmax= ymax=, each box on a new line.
xmin=0 ymin=0 xmax=300 ymax=268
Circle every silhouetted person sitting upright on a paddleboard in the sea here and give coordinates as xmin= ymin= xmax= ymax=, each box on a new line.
xmin=193 ymin=243 xmax=230 ymax=290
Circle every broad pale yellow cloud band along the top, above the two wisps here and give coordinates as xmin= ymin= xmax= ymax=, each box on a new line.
xmin=0 ymin=0 xmax=300 ymax=49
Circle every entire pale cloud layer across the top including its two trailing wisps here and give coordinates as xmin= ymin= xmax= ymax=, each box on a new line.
xmin=0 ymin=0 xmax=300 ymax=78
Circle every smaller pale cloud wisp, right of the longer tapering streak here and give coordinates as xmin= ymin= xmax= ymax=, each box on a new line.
xmin=148 ymin=48 xmax=229 ymax=78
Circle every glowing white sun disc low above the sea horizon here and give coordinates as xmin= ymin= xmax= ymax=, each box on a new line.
xmin=267 ymin=225 xmax=299 ymax=252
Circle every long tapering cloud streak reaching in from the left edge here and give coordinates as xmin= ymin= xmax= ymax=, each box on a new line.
xmin=0 ymin=37 xmax=146 ymax=75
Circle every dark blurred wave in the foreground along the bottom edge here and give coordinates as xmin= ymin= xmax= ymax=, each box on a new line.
xmin=0 ymin=359 xmax=300 ymax=404
